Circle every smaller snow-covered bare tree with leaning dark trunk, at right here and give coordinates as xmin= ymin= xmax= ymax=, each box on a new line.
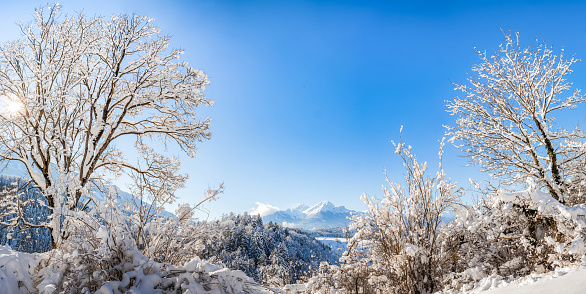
xmin=447 ymin=34 xmax=586 ymax=203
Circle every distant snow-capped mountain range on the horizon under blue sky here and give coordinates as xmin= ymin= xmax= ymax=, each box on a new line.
xmin=263 ymin=201 xmax=362 ymax=230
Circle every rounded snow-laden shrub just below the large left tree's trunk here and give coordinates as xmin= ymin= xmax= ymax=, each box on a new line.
xmin=34 ymin=189 xmax=137 ymax=293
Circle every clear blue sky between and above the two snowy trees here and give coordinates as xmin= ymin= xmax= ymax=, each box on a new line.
xmin=0 ymin=0 xmax=586 ymax=218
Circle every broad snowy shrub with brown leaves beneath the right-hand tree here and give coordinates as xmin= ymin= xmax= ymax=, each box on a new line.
xmin=445 ymin=179 xmax=586 ymax=290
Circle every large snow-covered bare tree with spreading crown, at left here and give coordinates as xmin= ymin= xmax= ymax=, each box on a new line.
xmin=0 ymin=5 xmax=213 ymax=246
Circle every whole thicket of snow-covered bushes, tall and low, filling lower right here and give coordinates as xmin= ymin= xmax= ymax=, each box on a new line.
xmin=298 ymin=145 xmax=586 ymax=293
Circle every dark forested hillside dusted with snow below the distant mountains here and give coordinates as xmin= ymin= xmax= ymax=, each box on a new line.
xmin=198 ymin=213 xmax=337 ymax=286
